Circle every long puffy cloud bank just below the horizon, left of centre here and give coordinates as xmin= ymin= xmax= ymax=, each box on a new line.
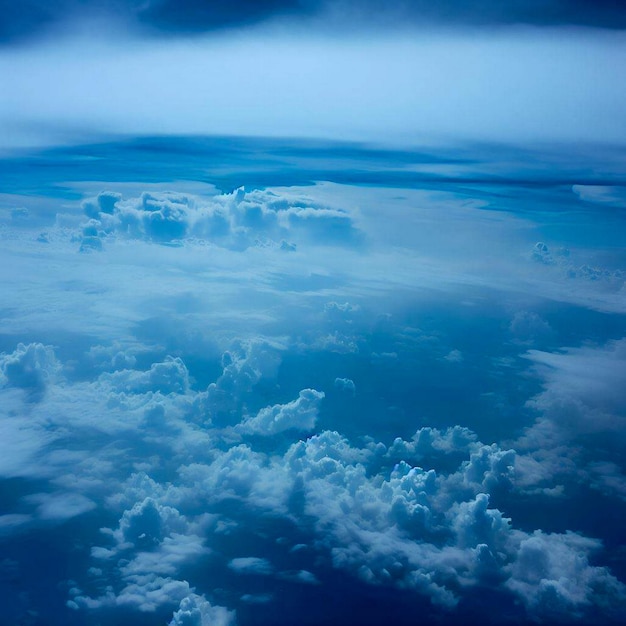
xmin=81 ymin=188 xmax=359 ymax=250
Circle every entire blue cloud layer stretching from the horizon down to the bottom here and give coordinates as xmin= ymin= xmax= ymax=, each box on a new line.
xmin=0 ymin=142 xmax=626 ymax=626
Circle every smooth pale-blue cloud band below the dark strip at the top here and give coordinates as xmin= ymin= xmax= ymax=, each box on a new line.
xmin=0 ymin=30 xmax=625 ymax=147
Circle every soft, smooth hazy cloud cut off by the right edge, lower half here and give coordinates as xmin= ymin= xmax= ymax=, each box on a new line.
xmin=514 ymin=339 xmax=626 ymax=497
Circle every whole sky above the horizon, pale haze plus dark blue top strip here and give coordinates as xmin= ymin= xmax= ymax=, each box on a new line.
xmin=0 ymin=0 xmax=626 ymax=145
